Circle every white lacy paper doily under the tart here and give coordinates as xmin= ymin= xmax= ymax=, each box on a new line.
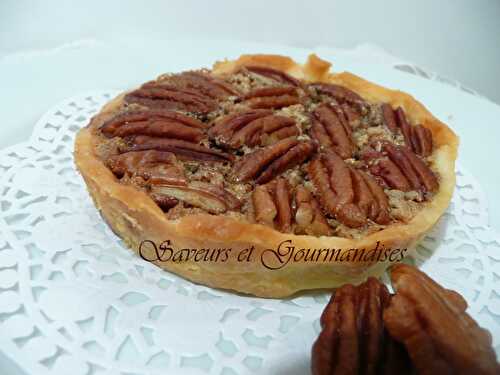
xmin=0 ymin=92 xmax=500 ymax=375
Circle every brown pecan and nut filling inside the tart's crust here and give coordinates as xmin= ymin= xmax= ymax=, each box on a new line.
xmin=97 ymin=66 xmax=439 ymax=236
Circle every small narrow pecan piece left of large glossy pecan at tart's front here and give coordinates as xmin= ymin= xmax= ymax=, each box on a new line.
xmin=295 ymin=185 xmax=332 ymax=236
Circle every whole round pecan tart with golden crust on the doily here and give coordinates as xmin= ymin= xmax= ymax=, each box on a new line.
xmin=75 ymin=55 xmax=458 ymax=297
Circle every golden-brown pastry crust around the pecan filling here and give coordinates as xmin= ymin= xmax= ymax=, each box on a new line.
xmin=75 ymin=55 xmax=458 ymax=297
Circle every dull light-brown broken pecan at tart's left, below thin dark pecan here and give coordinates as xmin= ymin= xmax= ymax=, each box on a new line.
xmin=106 ymin=150 xmax=186 ymax=185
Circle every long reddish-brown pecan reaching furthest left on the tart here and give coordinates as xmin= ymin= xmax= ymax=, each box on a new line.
xmin=101 ymin=110 xmax=206 ymax=143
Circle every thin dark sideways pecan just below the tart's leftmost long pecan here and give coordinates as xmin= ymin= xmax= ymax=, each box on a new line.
xmin=125 ymin=135 xmax=233 ymax=162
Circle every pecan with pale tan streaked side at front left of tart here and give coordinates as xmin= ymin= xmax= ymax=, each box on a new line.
xmin=151 ymin=181 xmax=241 ymax=214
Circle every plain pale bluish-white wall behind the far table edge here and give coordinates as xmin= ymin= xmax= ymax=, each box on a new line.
xmin=0 ymin=0 xmax=500 ymax=103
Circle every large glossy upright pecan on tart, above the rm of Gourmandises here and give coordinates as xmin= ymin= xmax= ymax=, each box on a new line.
xmin=308 ymin=151 xmax=366 ymax=228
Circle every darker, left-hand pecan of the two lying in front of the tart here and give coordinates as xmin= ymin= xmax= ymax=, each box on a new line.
xmin=311 ymin=278 xmax=411 ymax=375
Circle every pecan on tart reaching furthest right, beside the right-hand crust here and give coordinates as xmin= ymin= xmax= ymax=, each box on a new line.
xmin=370 ymin=143 xmax=439 ymax=192
